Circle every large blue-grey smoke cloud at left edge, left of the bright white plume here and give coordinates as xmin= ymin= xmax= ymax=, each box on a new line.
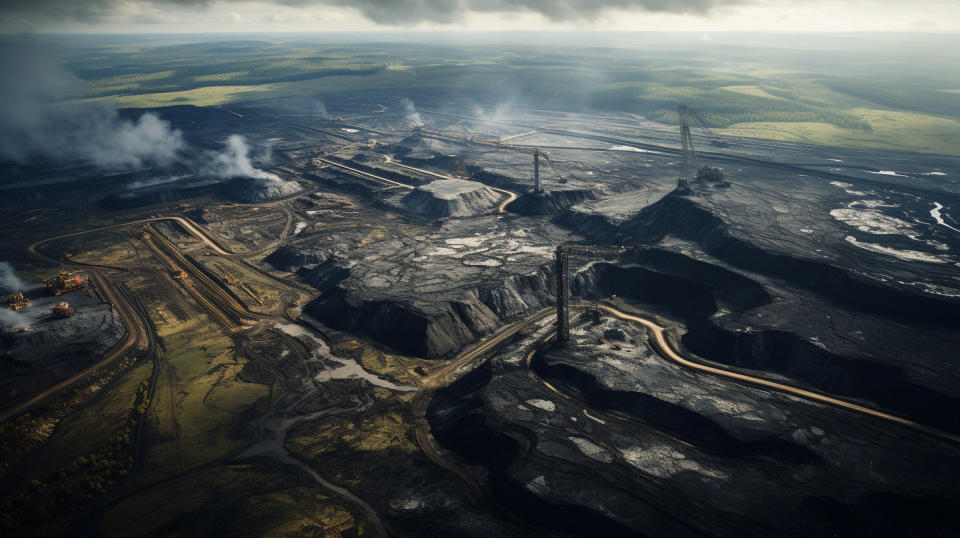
xmin=0 ymin=43 xmax=185 ymax=170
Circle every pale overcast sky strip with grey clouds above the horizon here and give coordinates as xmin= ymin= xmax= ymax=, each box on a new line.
xmin=0 ymin=0 xmax=960 ymax=33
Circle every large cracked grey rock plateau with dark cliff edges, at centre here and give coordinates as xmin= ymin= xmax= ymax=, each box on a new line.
xmin=302 ymin=216 xmax=569 ymax=358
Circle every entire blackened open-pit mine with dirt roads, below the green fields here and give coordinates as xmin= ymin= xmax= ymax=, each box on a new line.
xmin=0 ymin=94 xmax=960 ymax=538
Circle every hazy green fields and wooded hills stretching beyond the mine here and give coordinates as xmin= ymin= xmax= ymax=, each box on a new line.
xmin=50 ymin=38 xmax=960 ymax=154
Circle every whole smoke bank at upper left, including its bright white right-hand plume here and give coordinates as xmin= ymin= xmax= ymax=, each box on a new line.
xmin=0 ymin=36 xmax=284 ymax=188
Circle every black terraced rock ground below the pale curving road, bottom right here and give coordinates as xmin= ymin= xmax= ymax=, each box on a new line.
xmin=428 ymin=318 xmax=960 ymax=538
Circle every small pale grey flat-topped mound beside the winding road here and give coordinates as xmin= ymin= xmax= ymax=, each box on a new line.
xmin=401 ymin=179 xmax=503 ymax=218
